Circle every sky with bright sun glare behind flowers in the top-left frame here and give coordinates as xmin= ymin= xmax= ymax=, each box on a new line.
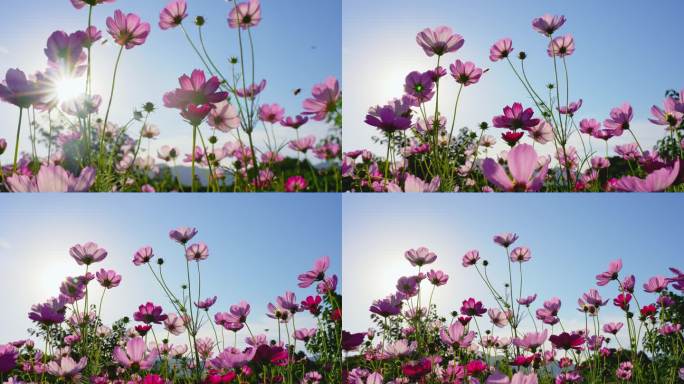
xmin=0 ymin=0 xmax=341 ymax=163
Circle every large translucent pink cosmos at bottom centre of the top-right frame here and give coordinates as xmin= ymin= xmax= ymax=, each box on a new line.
xmin=482 ymin=144 xmax=549 ymax=192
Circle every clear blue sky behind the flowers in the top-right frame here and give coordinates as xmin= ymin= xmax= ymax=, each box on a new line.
xmin=343 ymin=0 xmax=684 ymax=154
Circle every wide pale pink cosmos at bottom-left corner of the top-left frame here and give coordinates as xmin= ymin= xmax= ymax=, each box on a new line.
xmin=5 ymin=165 xmax=95 ymax=192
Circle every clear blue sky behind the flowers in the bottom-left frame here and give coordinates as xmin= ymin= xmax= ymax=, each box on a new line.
xmin=0 ymin=194 xmax=341 ymax=343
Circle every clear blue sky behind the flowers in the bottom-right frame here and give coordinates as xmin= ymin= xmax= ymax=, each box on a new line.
xmin=342 ymin=194 xmax=684 ymax=344
